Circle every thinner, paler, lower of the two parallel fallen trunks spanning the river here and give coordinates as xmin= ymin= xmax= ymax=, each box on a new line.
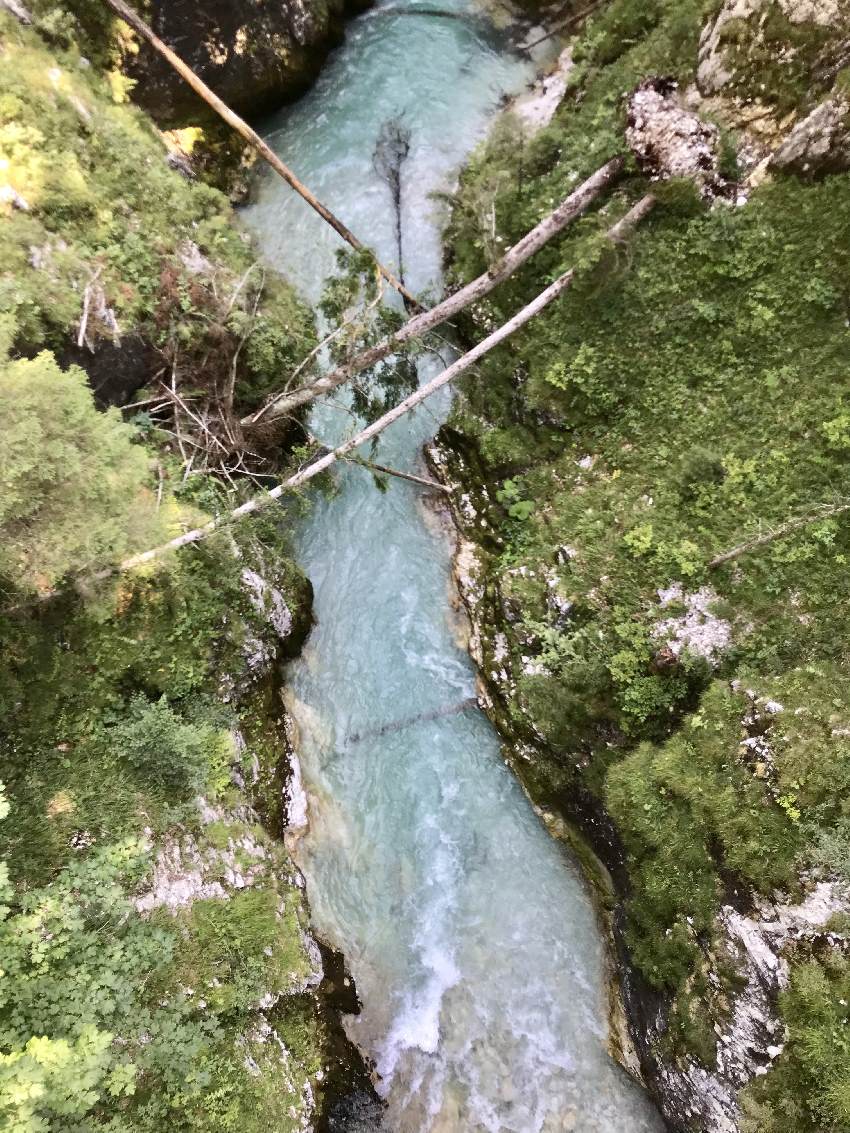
xmin=116 ymin=195 xmax=655 ymax=578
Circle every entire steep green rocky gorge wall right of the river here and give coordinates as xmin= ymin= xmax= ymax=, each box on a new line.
xmin=431 ymin=0 xmax=850 ymax=1133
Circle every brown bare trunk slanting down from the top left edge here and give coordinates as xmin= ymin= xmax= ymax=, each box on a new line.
xmin=99 ymin=0 xmax=422 ymax=310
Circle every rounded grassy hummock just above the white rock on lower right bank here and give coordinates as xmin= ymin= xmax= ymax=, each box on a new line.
xmin=605 ymin=682 xmax=800 ymax=989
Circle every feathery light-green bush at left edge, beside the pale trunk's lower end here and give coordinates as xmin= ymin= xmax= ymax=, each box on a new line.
xmin=0 ymin=353 xmax=162 ymax=589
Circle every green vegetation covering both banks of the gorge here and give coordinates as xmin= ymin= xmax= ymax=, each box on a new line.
xmin=0 ymin=0 xmax=850 ymax=1133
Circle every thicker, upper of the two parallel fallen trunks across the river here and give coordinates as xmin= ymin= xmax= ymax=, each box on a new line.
xmin=241 ymin=157 xmax=623 ymax=429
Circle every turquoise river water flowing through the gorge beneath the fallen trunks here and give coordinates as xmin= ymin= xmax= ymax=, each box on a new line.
xmin=247 ymin=0 xmax=661 ymax=1133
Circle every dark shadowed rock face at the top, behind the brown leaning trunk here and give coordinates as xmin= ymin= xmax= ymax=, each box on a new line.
xmin=129 ymin=0 xmax=368 ymax=126
